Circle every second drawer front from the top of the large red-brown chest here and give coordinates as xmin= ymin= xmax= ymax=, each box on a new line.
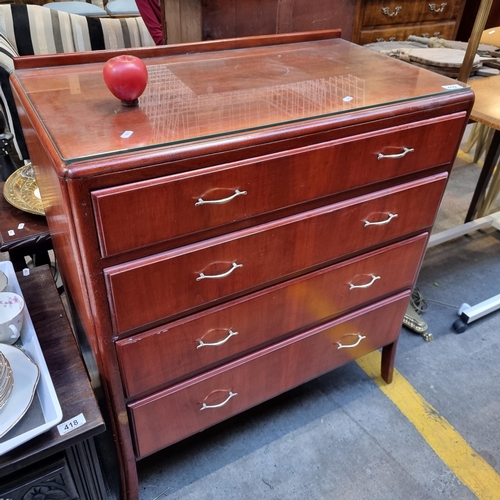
xmin=104 ymin=173 xmax=447 ymax=333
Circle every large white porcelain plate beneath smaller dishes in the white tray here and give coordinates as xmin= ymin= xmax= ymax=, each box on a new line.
xmin=0 ymin=344 xmax=40 ymax=437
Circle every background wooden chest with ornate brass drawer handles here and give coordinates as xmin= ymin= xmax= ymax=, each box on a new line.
xmin=352 ymin=0 xmax=465 ymax=45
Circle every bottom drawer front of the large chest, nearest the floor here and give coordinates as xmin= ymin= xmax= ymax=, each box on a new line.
xmin=129 ymin=292 xmax=410 ymax=458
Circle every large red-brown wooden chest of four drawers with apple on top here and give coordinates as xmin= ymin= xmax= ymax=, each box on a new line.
xmin=12 ymin=32 xmax=473 ymax=499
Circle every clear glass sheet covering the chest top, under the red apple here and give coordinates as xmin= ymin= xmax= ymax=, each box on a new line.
xmin=17 ymin=39 xmax=466 ymax=162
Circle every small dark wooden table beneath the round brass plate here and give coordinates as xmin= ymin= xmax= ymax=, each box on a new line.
xmin=0 ymin=182 xmax=52 ymax=271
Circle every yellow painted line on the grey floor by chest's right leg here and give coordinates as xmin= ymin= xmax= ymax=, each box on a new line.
xmin=356 ymin=351 xmax=500 ymax=500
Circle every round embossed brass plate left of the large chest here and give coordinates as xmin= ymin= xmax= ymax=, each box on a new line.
xmin=3 ymin=163 xmax=45 ymax=215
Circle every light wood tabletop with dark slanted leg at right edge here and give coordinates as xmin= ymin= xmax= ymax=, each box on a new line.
xmin=465 ymin=75 xmax=500 ymax=222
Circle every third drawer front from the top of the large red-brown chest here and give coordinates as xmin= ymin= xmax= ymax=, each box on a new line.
xmin=116 ymin=233 xmax=427 ymax=397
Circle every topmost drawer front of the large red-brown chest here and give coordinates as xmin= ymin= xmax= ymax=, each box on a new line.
xmin=92 ymin=115 xmax=463 ymax=256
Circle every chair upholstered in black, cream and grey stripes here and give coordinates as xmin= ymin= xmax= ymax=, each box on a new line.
xmin=0 ymin=4 xmax=155 ymax=160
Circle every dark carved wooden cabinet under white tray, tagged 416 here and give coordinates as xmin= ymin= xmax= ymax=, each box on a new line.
xmin=0 ymin=266 xmax=109 ymax=500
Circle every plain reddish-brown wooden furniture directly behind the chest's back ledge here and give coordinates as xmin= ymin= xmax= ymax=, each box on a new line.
xmin=161 ymin=0 xmax=356 ymax=44
